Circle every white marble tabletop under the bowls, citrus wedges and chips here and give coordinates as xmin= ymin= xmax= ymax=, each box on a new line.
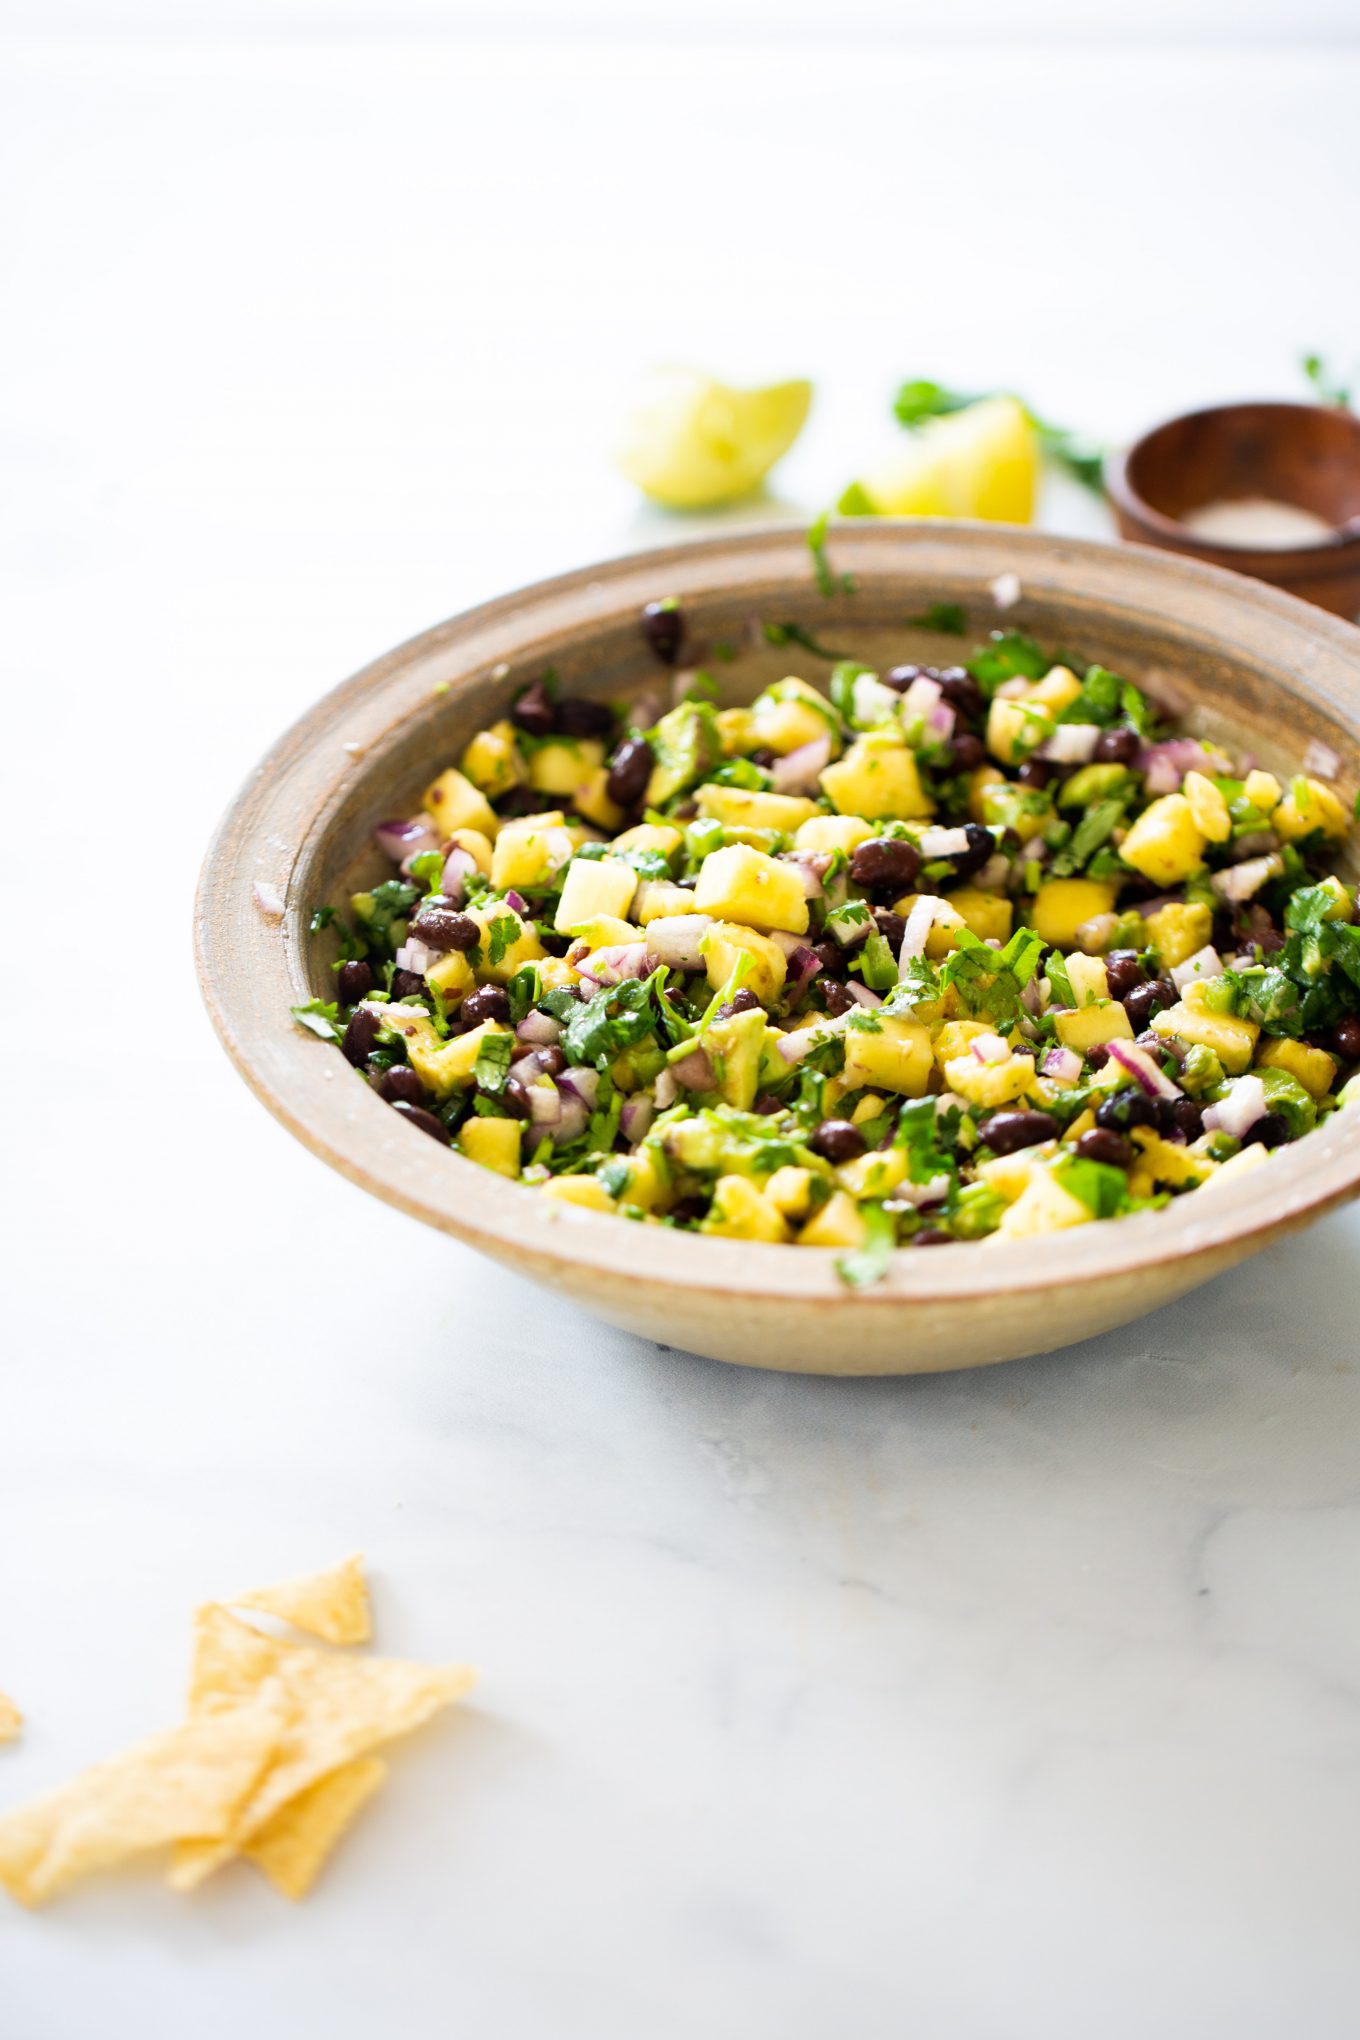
xmin=0 ymin=23 xmax=1360 ymax=2040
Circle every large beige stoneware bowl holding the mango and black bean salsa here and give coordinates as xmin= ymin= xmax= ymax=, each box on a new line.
xmin=198 ymin=520 xmax=1360 ymax=1375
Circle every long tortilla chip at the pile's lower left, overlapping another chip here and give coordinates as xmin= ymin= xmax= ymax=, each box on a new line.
xmin=0 ymin=1679 xmax=290 ymax=1905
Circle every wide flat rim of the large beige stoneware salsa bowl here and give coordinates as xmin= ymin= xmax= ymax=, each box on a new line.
xmin=194 ymin=518 xmax=1360 ymax=1312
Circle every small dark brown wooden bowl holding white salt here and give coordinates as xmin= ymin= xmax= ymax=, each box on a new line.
xmin=1105 ymin=404 xmax=1360 ymax=622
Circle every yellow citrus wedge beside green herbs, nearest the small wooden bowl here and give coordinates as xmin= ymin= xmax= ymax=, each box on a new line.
xmin=838 ymin=396 xmax=1040 ymax=524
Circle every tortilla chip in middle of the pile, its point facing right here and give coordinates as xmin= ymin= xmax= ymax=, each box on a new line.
xmin=169 ymin=1603 xmax=477 ymax=1891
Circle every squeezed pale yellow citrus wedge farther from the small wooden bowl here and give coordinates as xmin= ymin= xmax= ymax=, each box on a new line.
xmin=618 ymin=369 xmax=812 ymax=510
